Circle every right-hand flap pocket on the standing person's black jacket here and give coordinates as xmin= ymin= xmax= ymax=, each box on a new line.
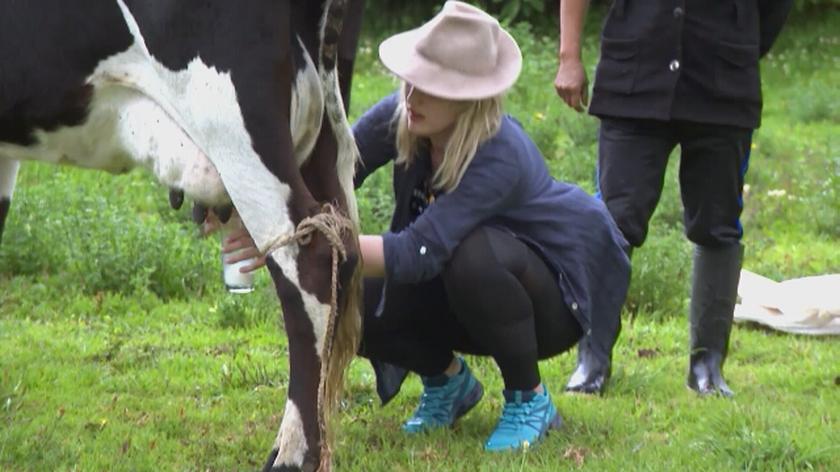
xmin=715 ymin=41 xmax=761 ymax=102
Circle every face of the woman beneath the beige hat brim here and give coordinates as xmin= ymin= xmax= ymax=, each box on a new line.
xmin=405 ymin=83 xmax=467 ymax=144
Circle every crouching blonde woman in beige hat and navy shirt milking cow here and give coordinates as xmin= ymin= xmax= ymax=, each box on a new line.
xmin=226 ymin=1 xmax=630 ymax=451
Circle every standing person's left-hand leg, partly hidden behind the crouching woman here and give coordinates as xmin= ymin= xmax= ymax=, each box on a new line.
xmin=566 ymin=118 xmax=676 ymax=393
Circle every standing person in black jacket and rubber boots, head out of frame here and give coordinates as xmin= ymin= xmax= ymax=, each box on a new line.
xmin=554 ymin=0 xmax=792 ymax=396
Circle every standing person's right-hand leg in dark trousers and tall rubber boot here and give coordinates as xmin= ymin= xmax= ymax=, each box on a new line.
xmin=680 ymin=123 xmax=752 ymax=396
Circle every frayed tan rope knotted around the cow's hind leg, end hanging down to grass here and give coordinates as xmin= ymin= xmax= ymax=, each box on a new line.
xmin=266 ymin=203 xmax=355 ymax=472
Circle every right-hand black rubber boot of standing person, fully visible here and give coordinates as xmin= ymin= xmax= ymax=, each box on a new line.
xmin=688 ymin=244 xmax=744 ymax=397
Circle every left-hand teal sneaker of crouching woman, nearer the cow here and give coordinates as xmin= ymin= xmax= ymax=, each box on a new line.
xmin=403 ymin=357 xmax=484 ymax=434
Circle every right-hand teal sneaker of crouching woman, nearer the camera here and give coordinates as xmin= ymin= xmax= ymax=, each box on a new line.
xmin=484 ymin=385 xmax=563 ymax=451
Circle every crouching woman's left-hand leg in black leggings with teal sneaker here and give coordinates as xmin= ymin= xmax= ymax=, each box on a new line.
xmin=360 ymin=278 xmax=484 ymax=433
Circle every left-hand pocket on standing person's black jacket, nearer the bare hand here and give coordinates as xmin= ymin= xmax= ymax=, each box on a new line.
xmin=595 ymin=37 xmax=638 ymax=94
